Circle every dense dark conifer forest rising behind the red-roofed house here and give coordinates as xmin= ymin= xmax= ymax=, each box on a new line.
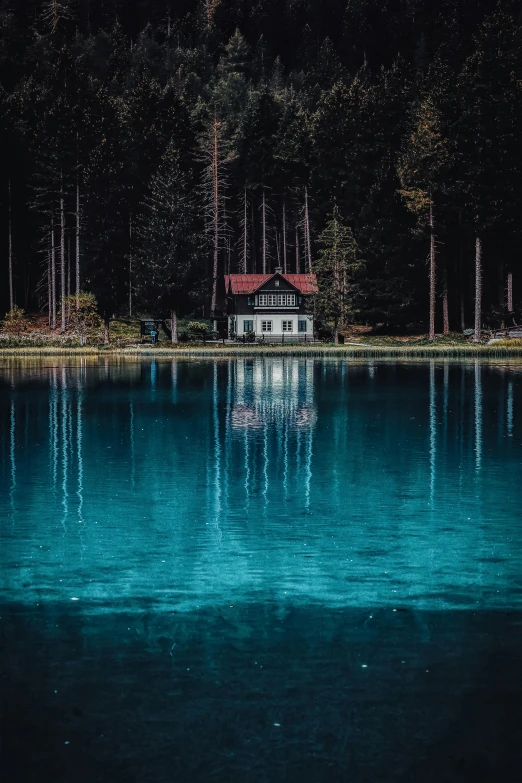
xmin=0 ymin=0 xmax=522 ymax=333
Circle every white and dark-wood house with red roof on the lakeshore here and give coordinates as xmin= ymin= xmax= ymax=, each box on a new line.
xmin=220 ymin=267 xmax=317 ymax=340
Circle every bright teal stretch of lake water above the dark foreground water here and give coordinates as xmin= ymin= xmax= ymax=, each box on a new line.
xmin=0 ymin=358 xmax=522 ymax=610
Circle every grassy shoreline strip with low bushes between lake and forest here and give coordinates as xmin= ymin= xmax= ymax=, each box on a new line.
xmin=0 ymin=316 xmax=522 ymax=356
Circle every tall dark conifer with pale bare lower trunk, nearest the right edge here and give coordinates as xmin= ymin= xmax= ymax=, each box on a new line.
xmin=454 ymin=6 xmax=522 ymax=342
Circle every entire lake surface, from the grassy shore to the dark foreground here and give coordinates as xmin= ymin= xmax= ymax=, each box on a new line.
xmin=0 ymin=356 xmax=522 ymax=783
